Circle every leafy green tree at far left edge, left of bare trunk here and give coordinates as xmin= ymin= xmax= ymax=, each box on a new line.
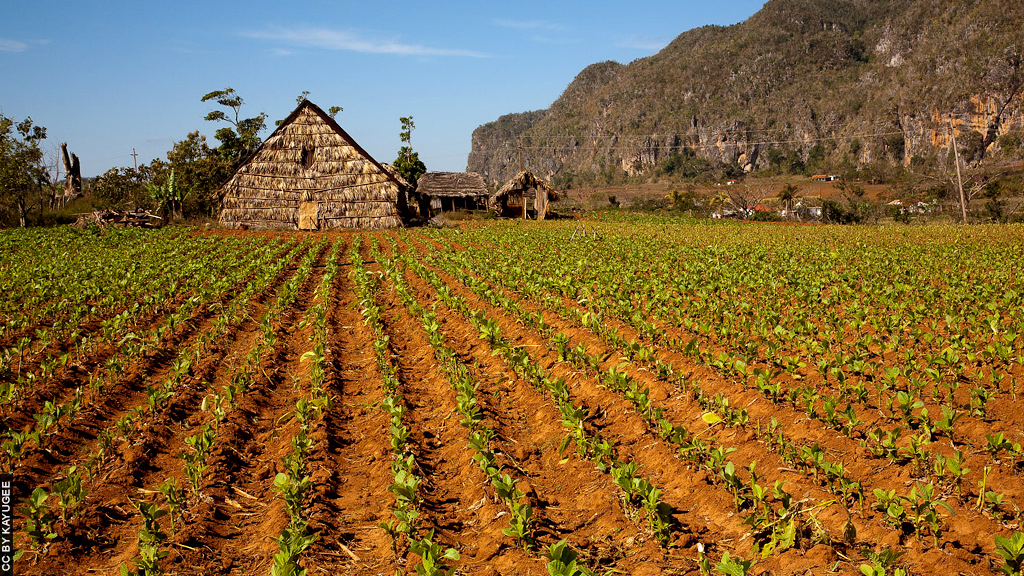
xmin=0 ymin=114 xmax=49 ymax=228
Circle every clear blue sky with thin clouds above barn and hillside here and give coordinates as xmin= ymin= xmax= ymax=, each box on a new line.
xmin=0 ymin=0 xmax=762 ymax=175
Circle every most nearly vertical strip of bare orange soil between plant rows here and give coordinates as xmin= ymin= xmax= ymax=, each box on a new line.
xmin=305 ymin=238 xmax=403 ymax=576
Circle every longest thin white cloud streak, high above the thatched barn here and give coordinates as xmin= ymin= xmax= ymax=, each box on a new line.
xmin=241 ymin=28 xmax=487 ymax=58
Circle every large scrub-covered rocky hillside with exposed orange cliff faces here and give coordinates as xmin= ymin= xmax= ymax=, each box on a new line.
xmin=468 ymin=0 xmax=1024 ymax=183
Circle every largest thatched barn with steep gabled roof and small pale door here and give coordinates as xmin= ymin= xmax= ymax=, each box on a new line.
xmin=220 ymin=100 xmax=406 ymax=230
